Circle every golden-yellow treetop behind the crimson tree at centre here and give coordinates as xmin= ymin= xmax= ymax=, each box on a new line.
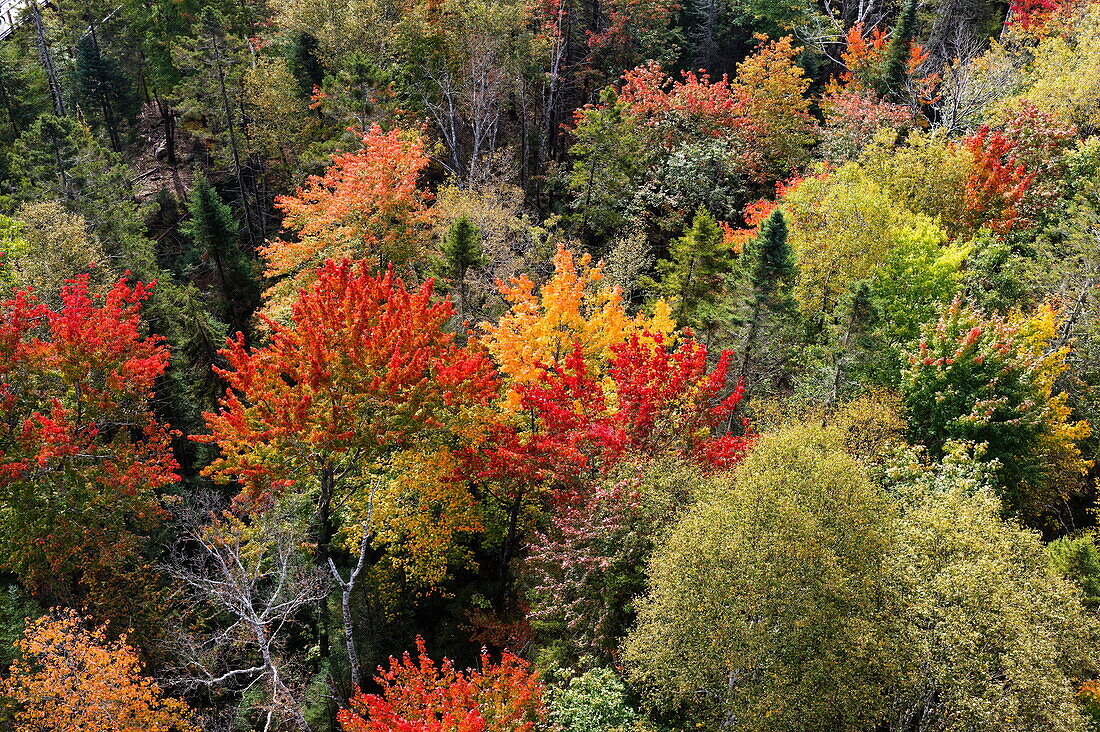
xmin=482 ymin=245 xmax=674 ymax=408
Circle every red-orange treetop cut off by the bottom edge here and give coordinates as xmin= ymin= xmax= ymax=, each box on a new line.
xmin=337 ymin=636 xmax=546 ymax=732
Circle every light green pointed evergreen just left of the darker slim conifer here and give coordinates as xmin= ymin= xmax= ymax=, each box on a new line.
xmin=642 ymin=207 xmax=736 ymax=341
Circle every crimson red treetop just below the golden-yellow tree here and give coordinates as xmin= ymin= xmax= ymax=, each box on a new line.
xmin=473 ymin=334 xmax=750 ymax=485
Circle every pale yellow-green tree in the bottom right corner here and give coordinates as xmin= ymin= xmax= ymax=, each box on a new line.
xmin=883 ymin=446 xmax=1100 ymax=732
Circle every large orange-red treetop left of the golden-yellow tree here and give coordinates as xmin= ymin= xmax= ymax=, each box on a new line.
xmin=196 ymin=256 xmax=497 ymax=501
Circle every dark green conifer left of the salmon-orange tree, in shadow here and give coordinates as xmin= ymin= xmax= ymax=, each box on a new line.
xmin=182 ymin=173 xmax=259 ymax=330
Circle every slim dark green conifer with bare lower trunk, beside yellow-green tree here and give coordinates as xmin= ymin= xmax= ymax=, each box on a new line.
xmin=740 ymin=208 xmax=795 ymax=380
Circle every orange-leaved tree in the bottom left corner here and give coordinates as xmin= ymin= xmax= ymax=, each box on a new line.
xmin=0 ymin=610 xmax=198 ymax=732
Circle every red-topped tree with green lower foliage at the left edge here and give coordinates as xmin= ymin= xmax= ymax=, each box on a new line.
xmin=0 ymin=276 xmax=178 ymax=631
